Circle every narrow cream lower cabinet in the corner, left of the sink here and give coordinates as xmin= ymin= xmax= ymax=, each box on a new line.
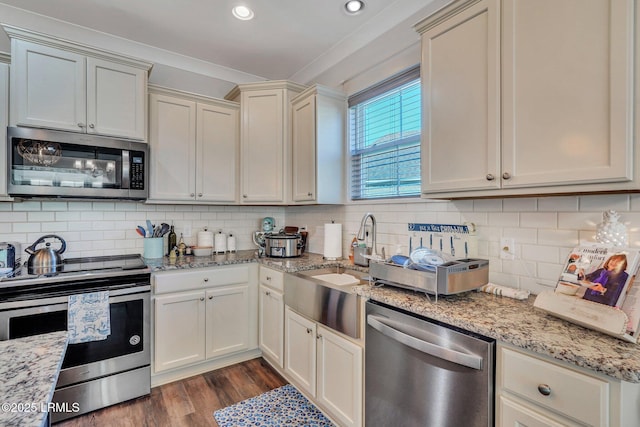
xmin=258 ymin=266 xmax=284 ymax=369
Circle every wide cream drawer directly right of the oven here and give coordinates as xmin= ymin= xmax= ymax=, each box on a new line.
xmin=153 ymin=266 xmax=249 ymax=294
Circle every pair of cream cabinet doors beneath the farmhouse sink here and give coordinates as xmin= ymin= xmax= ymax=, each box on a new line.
xmin=284 ymin=307 xmax=363 ymax=426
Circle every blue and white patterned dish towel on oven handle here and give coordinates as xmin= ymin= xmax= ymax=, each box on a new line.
xmin=67 ymin=291 xmax=111 ymax=344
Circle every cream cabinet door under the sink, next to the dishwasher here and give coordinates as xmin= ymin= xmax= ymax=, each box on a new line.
xmin=317 ymin=326 xmax=363 ymax=426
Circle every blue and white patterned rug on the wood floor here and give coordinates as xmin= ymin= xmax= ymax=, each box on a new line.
xmin=213 ymin=384 xmax=334 ymax=427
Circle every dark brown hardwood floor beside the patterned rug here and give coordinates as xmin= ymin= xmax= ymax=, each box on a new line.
xmin=54 ymin=358 xmax=287 ymax=427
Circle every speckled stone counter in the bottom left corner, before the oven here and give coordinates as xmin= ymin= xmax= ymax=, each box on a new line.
xmin=0 ymin=332 xmax=67 ymax=426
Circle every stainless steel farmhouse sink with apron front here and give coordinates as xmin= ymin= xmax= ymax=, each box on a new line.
xmin=284 ymin=267 xmax=368 ymax=338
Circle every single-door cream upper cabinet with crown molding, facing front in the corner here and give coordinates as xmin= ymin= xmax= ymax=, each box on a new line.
xmin=225 ymin=80 xmax=305 ymax=205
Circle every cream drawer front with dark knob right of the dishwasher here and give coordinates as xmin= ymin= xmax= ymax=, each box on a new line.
xmin=499 ymin=348 xmax=609 ymax=426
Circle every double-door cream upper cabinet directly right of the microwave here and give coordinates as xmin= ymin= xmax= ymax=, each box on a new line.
xmin=149 ymin=87 xmax=239 ymax=204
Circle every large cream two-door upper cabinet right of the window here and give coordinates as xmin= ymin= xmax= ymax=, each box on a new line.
xmin=416 ymin=0 xmax=640 ymax=198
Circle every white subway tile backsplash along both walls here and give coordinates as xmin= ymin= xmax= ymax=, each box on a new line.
xmin=0 ymin=195 xmax=640 ymax=293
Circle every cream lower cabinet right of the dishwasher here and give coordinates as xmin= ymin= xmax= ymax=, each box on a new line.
xmin=496 ymin=344 xmax=640 ymax=427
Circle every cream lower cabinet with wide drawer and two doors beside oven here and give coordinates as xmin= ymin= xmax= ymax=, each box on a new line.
xmin=153 ymin=265 xmax=257 ymax=373
